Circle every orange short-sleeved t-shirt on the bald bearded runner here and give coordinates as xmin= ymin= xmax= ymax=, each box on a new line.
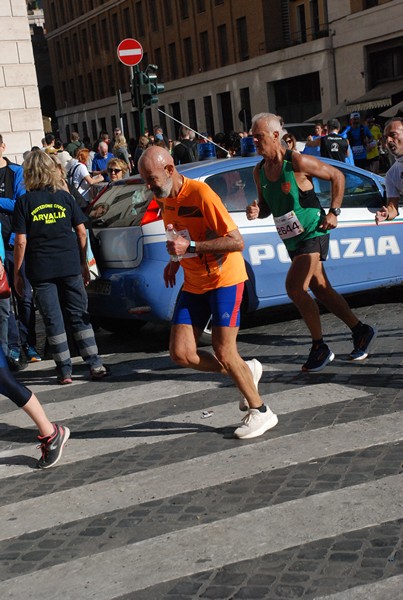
xmin=158 ymin=177 xmax=248 ymax=294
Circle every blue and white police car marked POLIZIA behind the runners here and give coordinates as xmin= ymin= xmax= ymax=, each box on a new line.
xmin=88 ymin=156 xmax=403 ymax=332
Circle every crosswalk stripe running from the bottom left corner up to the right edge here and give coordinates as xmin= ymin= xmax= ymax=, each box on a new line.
xmin=0 ymin=476 xmax=403 ymax=600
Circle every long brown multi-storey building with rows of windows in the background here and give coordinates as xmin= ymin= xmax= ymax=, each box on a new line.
xmin=42 ymin=0 xmax=403 ymax=139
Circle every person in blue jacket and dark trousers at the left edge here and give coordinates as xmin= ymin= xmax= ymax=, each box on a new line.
xmin=0 ymin=134 xmax=41 ymax=370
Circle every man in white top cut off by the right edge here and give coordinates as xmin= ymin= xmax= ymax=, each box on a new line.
xmin=375 ymin=117 xmax=403 ymax=225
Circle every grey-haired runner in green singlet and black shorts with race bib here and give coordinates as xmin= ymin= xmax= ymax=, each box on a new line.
xmin=246 ymin=113 xmax=377 ymax=372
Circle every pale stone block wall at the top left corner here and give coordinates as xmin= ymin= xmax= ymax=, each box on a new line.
xmin=0 ymin=0 xmax=43 ymax=163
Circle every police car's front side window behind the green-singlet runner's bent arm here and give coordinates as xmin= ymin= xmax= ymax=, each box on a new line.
xmin=313 ymin=169 xmax=383 ymax=208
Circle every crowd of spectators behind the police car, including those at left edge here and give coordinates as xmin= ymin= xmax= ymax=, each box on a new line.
xmin=0 ymin=112 xmax=400 ymax=370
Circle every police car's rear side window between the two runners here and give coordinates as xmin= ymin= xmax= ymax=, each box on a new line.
xmin=205 ymin=166 xmax=257 ymax=212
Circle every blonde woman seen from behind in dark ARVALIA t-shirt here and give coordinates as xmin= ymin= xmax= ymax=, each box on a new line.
xmin=13 ymin=150 xmax=108 ymax=385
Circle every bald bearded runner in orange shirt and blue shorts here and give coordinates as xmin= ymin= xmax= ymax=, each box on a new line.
xmin=138 ymin=146 xmax=277 ymax=439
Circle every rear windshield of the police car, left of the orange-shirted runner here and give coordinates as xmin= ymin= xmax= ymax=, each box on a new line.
xmin=89 ymin=183 xmax=153 ymax=227
